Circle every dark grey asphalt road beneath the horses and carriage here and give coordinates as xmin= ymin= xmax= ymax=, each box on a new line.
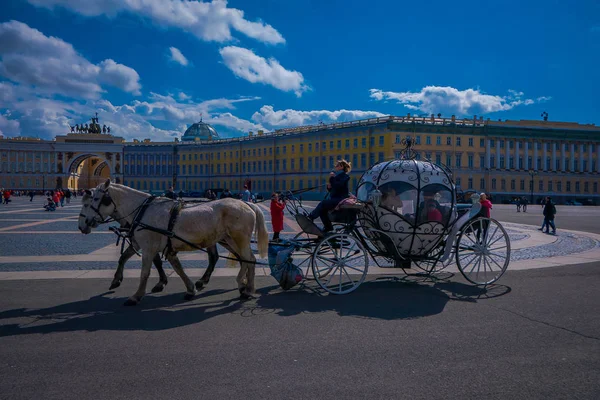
xmin=0 ymin=263 xmax=600 ymax=400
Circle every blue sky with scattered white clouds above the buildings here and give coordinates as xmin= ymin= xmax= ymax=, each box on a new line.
xmin=0 ymin=0 xmax=600 ymax=141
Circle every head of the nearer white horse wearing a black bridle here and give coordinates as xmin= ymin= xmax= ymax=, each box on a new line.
xmin=79 ymin=179 xmax=115 ymax=235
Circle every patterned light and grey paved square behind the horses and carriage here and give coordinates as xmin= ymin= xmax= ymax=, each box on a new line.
xmin=0 ymin=196 xmax=600 ymax=274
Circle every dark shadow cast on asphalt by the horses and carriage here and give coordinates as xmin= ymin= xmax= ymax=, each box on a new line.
xmin=0 ymin=277 xmax=511 ymax=337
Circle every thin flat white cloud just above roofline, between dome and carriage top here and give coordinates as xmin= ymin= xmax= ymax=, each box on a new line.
xmin=252 ymin=105 xmax=385 ymax=128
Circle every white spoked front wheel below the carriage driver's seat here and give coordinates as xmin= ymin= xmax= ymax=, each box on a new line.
xmin=311 ymin=233 xmax=369 ymax=294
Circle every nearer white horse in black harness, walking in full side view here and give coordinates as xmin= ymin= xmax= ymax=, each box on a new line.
xmin=79 ymin=179 xmax=269 ymax=305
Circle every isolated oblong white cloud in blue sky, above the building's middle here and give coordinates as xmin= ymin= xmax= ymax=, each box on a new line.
xmin=219 ymin=46 xmax=310 ymax=97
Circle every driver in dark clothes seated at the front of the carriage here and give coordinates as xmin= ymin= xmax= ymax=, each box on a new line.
xmin=308 ymin=159 xmax=352 ymax=232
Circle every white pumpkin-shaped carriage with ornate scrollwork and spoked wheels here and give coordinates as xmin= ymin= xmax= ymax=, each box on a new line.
xmin=269 ymin=149 xmax=510 ymax=294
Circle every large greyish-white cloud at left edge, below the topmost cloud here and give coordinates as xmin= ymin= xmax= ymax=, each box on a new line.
xmin=0 ymin=21 xmax=141 ymax=98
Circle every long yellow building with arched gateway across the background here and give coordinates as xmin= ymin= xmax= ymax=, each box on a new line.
xmin=0 ymin=115 xmax=600 ymax=204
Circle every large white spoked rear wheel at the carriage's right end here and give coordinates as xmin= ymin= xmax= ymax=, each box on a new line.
xmin=456 ymin=218 xmax=510 ymax=285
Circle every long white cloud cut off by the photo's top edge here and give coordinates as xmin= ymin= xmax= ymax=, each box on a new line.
xmin=28 ymin=0 xmax=285 ymax=44
